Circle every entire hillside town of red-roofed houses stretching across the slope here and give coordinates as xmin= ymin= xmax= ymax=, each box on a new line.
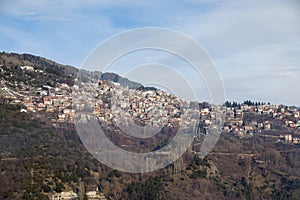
xmin=1 ymin=66 xmax=300 ymax=144
